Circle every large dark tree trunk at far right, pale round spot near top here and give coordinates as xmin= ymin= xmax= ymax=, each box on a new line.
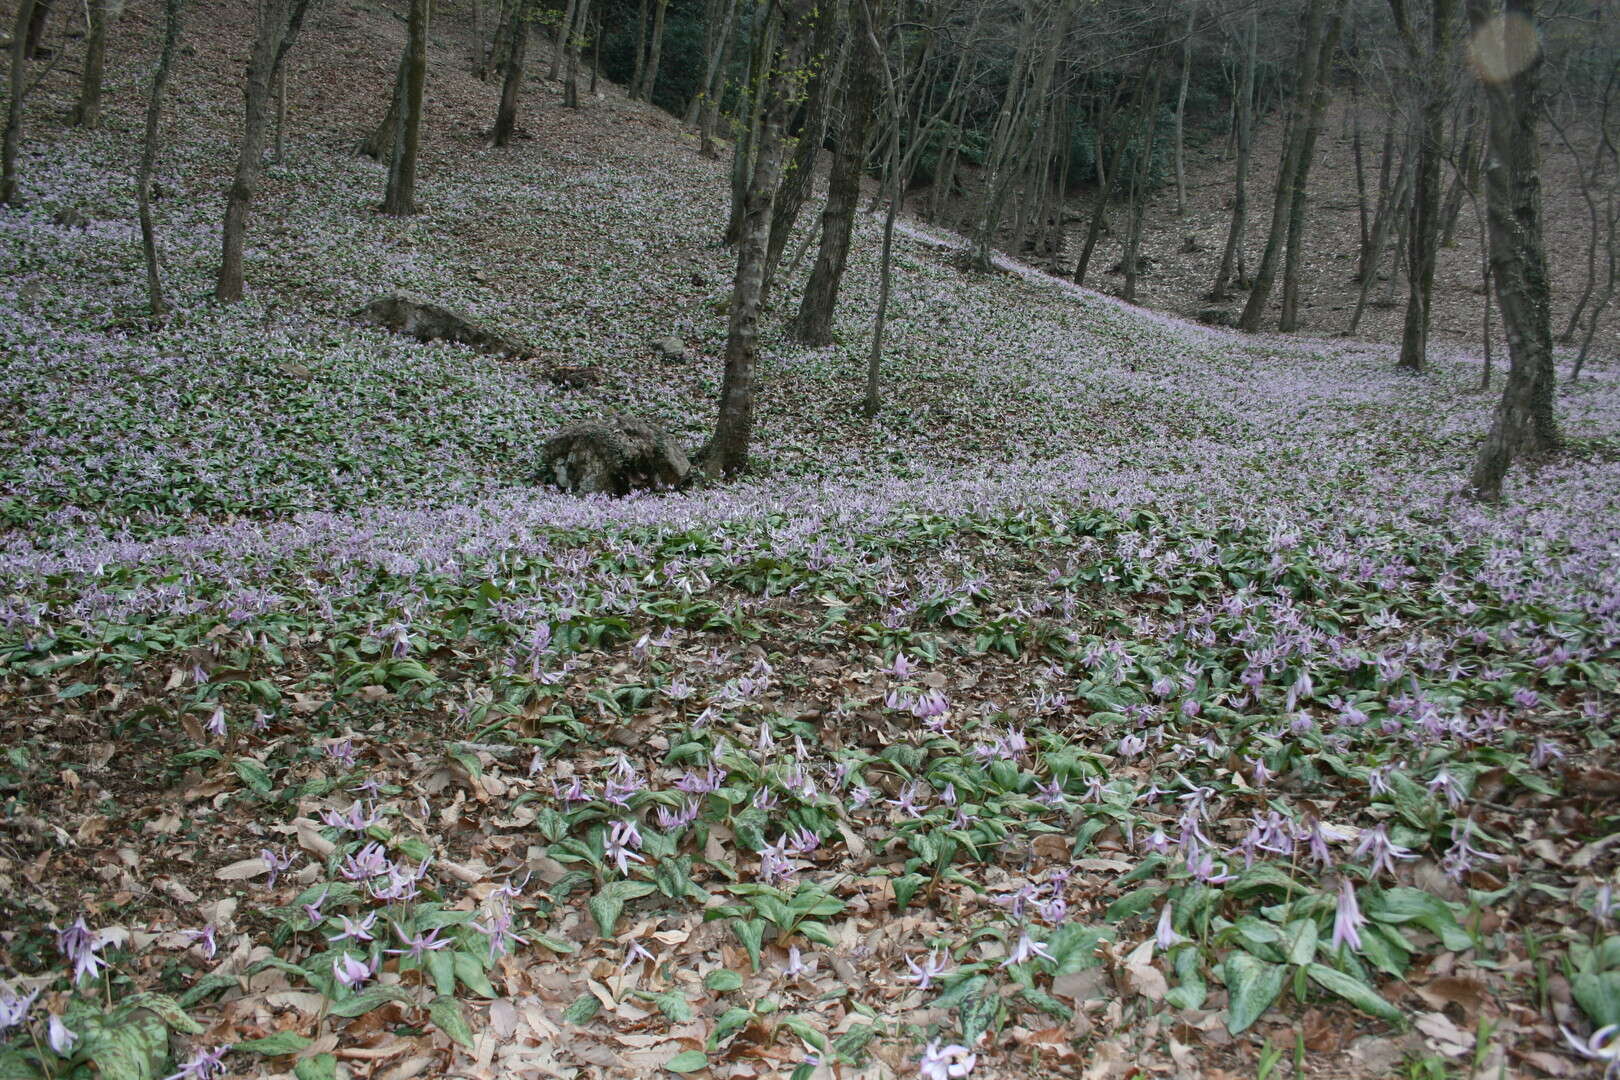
xmin=1468 ymin=0 xmax=1560 ymax=500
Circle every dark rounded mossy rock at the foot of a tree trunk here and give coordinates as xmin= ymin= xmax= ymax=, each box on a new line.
xmin=541 ymin=416 xmax=692 ymax=495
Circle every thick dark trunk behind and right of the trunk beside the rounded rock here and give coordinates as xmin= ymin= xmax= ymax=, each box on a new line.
xmin=792 ymin=0 xmax=881 ymax=345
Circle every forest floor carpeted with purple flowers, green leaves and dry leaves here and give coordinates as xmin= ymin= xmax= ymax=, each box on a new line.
xmin=0 ymin=3 xmax=1620 ymax=1080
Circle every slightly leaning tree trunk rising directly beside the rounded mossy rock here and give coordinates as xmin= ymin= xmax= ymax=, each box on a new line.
xmin=698 ymin=0 xmax=815 ymax=478
